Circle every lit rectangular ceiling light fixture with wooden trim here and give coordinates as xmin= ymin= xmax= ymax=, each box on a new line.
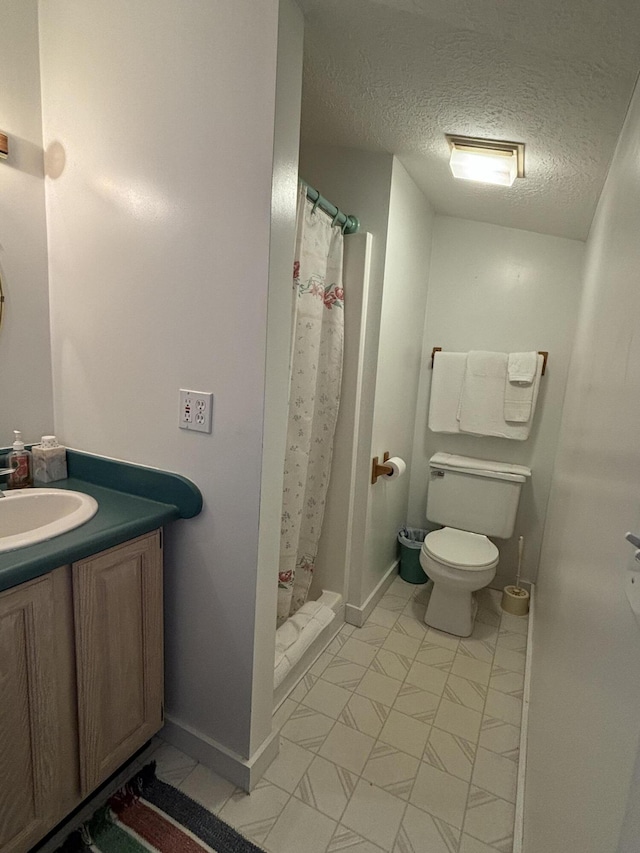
xmin=446 ymin=134 xmax=524 ymax=187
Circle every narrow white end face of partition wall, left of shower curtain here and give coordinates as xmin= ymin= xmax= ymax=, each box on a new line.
xmin=251 ymin=0 xmax=304 ymax=748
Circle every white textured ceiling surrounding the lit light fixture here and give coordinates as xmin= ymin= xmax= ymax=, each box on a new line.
xmin=298 ymin=0 xmax=640 ymax=240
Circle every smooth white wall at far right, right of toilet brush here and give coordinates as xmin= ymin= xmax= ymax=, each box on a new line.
xmin=525 ymin=75 xmax=640 ymax=853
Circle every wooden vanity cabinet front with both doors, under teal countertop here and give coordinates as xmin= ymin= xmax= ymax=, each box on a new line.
xmin=0 ymin=530 xmax=163 ymax=853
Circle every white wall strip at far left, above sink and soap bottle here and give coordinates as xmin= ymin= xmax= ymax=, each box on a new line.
xmin=0 ymin=0 xmax=53 ymax=447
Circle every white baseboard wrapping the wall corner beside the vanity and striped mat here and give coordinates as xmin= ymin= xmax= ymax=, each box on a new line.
xmin=162 ymin=714 xmax=280 ymax=793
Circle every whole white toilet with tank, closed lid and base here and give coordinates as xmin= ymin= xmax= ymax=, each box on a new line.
xmin=420 ymin=453 xmax=531 ymax=637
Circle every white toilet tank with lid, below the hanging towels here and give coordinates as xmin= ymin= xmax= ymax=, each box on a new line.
xmin=427 ymin=453 xmax=531 ymax=539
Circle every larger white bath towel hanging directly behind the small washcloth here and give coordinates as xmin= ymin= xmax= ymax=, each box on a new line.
xmin=458 ymin=350 xmax=537 ymax=441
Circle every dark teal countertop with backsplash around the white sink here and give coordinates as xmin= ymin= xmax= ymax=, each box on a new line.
xmin=0 ymin=451 xmax=202 ymax=591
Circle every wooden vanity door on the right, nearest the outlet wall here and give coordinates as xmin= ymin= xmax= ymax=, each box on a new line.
xmin=72 ymin=531 xmax=163 ymax=796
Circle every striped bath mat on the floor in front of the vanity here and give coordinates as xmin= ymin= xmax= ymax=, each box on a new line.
xmin=56 ymin=761 xmax=264 ymax=853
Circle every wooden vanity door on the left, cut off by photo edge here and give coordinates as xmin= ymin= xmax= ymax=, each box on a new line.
xmin=0 ymin=574 xmax=59 ymax=853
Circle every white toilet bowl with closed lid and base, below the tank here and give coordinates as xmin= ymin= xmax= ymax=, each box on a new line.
xmin=420 ymin=527 xmax=498 ymax=637
